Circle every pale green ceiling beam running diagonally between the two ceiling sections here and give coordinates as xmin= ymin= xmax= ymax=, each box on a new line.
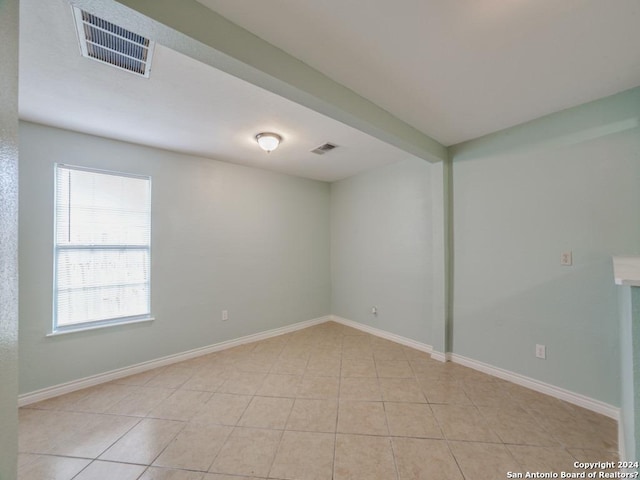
xmin=72 ymin=0 xmax=447 ymax=162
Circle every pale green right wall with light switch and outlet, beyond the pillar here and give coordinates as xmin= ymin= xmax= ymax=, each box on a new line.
xmin=451 ymin=89 xmax=640 ymax=406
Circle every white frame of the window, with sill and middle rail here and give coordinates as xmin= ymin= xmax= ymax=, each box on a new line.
xmin=47 ymin=163 xmax=154 ymax=336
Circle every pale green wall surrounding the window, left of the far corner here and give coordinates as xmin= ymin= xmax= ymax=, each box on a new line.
xmin=20 ymin=122 xmax=331 ymax=393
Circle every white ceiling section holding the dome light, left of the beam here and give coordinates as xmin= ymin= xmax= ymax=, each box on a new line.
xmin=19 ymin=0 xmax=411 ymax=181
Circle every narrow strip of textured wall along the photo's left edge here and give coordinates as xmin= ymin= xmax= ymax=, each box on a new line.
xmin=0 ymin=0 xmax=18 ymax=480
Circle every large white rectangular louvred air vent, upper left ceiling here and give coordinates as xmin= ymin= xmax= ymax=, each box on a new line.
xmin=73 ymin=7 xmax=154 ymax=78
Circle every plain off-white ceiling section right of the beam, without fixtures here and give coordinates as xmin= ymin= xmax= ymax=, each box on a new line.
xmin=198 ymin=0 xmax=640 ymax=145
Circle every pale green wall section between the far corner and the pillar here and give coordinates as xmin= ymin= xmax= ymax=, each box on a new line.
xmin=331 ymin=159 xmax=442 ymax=343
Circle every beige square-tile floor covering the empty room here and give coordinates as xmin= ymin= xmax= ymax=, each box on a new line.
xmin=19 ymin=323 xmax=617 ymax=480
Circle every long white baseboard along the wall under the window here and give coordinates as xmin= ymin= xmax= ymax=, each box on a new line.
xmin=18 ymin=315 xmax=331 ymax=407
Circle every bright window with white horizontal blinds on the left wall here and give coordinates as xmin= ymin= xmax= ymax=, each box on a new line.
xmin=53 ymin=165 xmax=151 ymax=333
